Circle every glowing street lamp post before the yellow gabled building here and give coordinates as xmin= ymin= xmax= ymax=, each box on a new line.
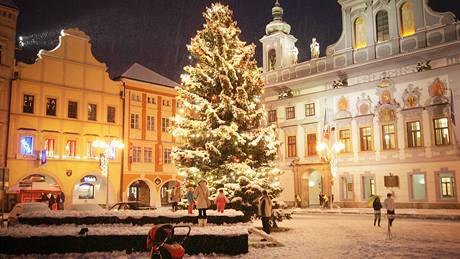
xmin=92 ymin=139 xmax=125 ymax=209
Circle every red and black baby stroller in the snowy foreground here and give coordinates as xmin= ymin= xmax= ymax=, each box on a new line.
xmin=147 ymin=225 xmax=191 ymax=259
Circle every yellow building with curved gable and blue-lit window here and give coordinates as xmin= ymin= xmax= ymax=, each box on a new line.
xmin=7 ymin=29 xmax=123 ymax=205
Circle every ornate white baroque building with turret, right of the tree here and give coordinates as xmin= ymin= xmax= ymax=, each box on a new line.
xmin=260 ymin=0 xmax=460 ymax=208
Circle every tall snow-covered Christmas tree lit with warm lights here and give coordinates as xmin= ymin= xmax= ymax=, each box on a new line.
xmin=172 ymin=3 xmax=281 ymax=215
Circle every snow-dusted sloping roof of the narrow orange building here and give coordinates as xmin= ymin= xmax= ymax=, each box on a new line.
xmin=120 ymin=63 xmax=179 ymax=87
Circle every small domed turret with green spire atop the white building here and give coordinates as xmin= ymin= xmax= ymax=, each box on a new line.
xmin=260 ymin=0 xmax=298 ymax=71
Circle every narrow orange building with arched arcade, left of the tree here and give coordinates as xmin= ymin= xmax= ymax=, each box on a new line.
xmin=118 ymin=63 xmax=178 ymax=207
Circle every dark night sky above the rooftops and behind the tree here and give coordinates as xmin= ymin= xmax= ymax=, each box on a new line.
xmin=15 ymin=0 xmax=460 ymax=81
